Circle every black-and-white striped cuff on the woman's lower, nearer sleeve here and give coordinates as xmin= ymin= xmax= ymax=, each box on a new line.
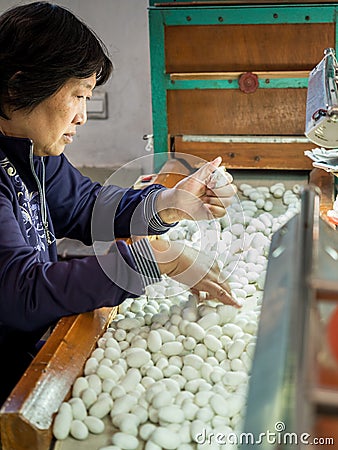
xmin=129 ymin=238 xmax=161 ymax=286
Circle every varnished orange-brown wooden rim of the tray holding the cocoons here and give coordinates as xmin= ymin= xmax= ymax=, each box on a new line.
xmin=0 ymin=160 xmax=333 ymax=450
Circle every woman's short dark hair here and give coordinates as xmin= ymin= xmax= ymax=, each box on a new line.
xmin=0 ymin=1 xmax=113 ymax=119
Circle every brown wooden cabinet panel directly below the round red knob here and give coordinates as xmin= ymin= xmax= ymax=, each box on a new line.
xmin=167 ymin=88 xmax=306 ymax=135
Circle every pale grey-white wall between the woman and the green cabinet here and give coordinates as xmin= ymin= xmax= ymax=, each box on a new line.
xmin=0 ymin=0 xmax=152 ymax=172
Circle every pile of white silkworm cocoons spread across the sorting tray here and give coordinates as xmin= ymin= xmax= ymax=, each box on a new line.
xmin=53 ymin=179 xmax=300 ymax=450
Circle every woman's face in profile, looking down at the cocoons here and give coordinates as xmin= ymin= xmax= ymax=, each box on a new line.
xmin=1 ymin=75 xmax=96 ymax=156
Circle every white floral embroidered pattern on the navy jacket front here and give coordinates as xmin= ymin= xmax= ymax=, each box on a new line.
xmin=0 ymin=158 xmax=47 ymax=252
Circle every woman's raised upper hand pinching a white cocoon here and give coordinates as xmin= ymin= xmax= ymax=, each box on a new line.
xmin=156 ymin=157 xmax=237 ymax=223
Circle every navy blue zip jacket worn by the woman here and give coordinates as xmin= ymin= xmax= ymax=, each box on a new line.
xmin=0 ymin=136 xmax=167 ymax=358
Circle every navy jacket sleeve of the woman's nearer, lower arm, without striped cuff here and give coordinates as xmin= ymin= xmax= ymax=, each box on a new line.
xmin=0 ymin=181 xmax=151 ymax=331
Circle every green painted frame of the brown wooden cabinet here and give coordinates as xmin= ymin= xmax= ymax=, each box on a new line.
xmin=148 ymin=0 xmax=338 ymax=171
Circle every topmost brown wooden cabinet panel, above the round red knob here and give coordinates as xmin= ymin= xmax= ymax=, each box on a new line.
xmin=164 ymin=23 xmax=335 ymax=73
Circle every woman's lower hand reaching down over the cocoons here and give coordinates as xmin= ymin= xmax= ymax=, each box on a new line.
xmin=150 ymin=239 xmax=242 ymax=308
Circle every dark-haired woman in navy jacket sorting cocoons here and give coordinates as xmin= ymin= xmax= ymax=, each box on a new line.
xmin=0 ymin=2 xmax=235 ymax=402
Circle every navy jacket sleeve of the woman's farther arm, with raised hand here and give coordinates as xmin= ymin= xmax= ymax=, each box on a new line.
xmin=46 ymin=155 xmax=173 ymax=245
